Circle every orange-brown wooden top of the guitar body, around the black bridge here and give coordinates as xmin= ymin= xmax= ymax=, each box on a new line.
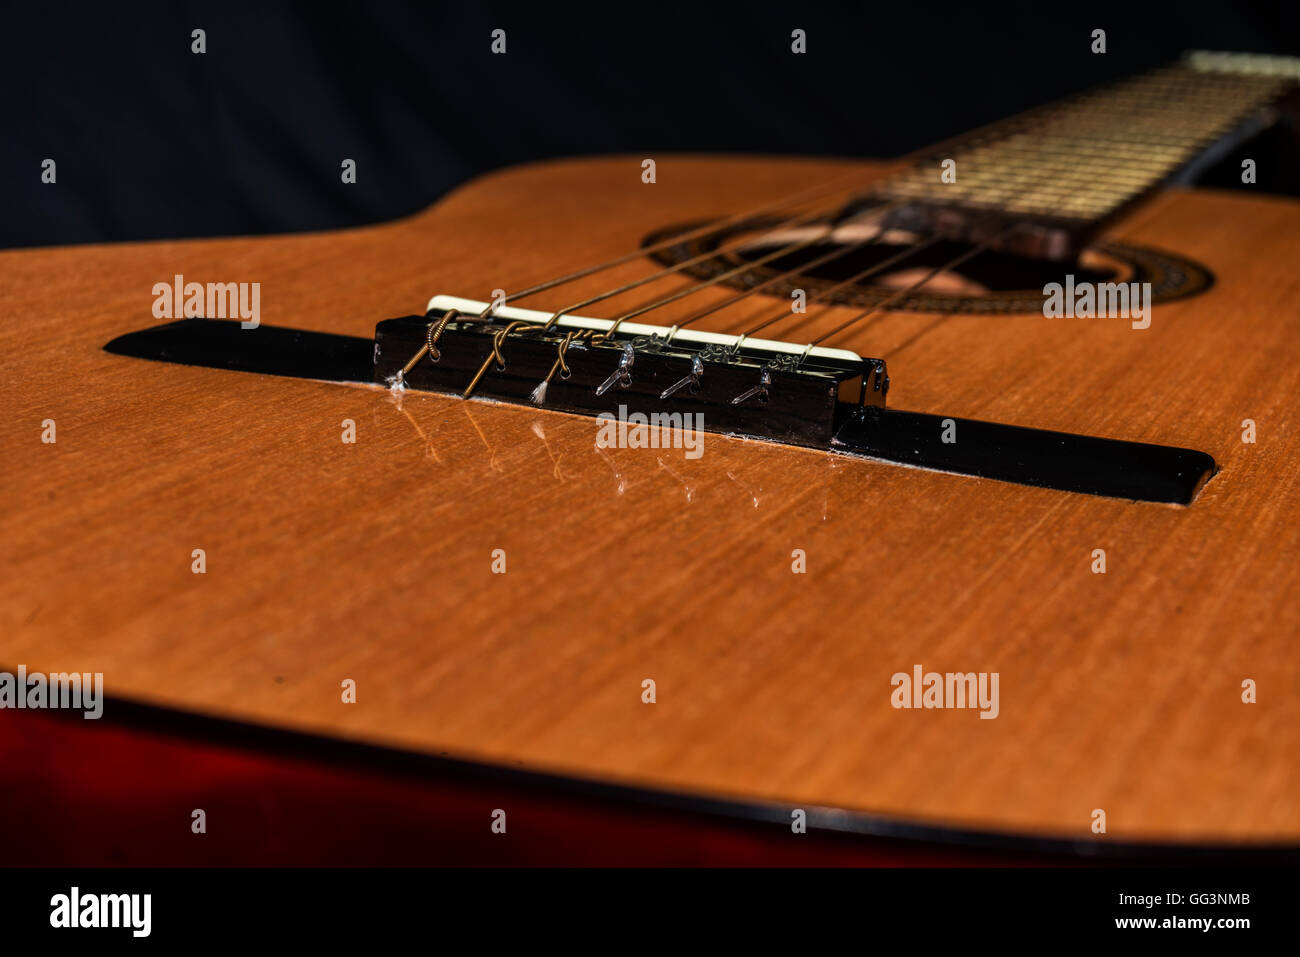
xmin=0 ymin=156 xmax=1300 ymax=843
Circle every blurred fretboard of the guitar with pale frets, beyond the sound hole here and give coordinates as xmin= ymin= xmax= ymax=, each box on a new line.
xmin=875 ymin=53 xmax=1300 ymax=257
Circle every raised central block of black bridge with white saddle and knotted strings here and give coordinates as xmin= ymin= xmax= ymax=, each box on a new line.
xmin=374 ymin=296 xmax=889 ymax=449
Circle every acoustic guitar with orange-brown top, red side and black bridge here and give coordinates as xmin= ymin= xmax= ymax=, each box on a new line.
xmin=0 ymin=53 xmax=1300 ymax=862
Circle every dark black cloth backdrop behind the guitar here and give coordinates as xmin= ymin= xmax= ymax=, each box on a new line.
xmin=0 ymin=0 xmax=1300 ymax=247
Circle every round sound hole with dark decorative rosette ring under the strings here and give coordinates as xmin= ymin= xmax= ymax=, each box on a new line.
xmin=642 ymin=220 xmax=1214 ymax=313
